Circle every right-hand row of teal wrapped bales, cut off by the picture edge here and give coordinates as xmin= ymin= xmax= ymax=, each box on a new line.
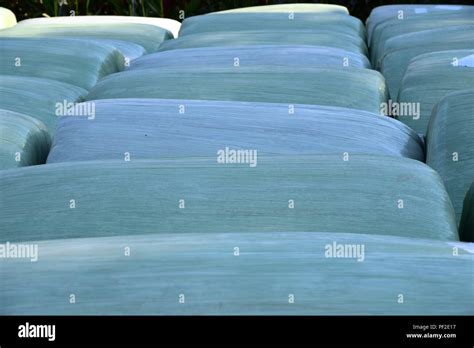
xmin=367 ymin=5 xmax=474 ymax=241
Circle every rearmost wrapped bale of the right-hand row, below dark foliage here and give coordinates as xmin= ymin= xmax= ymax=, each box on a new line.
xmin=366 ymin=4 xmax=474 ymax=42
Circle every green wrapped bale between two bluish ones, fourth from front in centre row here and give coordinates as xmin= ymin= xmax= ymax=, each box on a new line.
xmin=87 ymin=66 xmax=387 ymax=113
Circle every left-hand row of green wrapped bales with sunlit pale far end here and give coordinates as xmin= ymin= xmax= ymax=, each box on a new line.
xmin=0 ymin=17 xmax=177 ymax=168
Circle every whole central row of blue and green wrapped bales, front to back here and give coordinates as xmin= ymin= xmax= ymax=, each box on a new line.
xmin=0 ymin=4 xmax=474 ymax=314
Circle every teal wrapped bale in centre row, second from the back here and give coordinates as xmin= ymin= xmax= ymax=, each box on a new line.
xmin=179 ymin=13 xmax=365 ymax=38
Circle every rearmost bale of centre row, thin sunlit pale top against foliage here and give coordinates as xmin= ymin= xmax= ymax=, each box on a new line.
xmin=215 ymin=4 xmax=349 ymax=15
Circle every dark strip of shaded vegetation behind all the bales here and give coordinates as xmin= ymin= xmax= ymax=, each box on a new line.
xmin=0 ymin=0 xmax=473 ymax=21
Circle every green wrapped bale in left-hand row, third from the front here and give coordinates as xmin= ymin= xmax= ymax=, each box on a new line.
xmin=0 ymin=38 xmax=125 ymax=89
